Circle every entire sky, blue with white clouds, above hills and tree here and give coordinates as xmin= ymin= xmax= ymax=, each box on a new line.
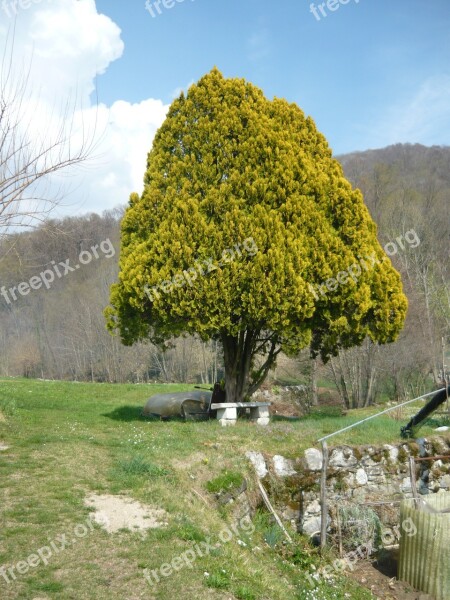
xmin=0 ymin=0 xmax=450 ymax=214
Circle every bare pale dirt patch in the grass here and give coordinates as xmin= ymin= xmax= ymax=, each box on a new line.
xmin=85 ymin=494 xmax=168 ymax=533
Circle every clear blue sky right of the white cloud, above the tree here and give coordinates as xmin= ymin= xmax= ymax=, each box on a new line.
xmin=93 ymin=0 xmax=450 ymax=153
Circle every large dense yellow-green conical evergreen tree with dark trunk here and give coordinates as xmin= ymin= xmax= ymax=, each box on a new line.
xmin=105 ymin=69 xmax=407 ymax=401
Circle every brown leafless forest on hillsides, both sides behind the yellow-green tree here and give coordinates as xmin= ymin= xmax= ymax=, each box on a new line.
xmin=0 ymin=144 xmax=450 ymax=406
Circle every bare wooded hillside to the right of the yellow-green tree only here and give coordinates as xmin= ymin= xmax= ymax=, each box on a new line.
xmin=342 ymin=144 xmax=450 ymax=398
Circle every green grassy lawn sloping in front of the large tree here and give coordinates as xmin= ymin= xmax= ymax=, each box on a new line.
xmin=0 ymin=379 xmax=442 ymax=600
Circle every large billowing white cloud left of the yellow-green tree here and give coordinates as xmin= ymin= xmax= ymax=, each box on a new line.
xmin=0 ymin=0 xmax=168 ymax=220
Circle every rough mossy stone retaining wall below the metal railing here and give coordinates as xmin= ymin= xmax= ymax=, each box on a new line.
xmin=247 ymin=437 xmax=450 ymax=544
